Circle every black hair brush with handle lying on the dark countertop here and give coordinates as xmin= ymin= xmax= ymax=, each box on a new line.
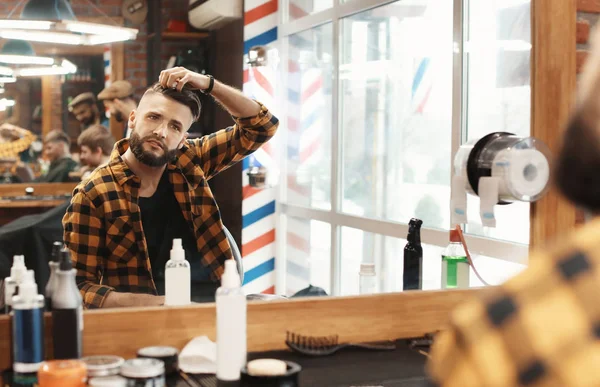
xmin=285 ymin=332 xmax=396 ymax=356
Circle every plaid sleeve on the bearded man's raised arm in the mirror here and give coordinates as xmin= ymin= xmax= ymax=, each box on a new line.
xmin=184 ymin=103 xmax=279 ymax=179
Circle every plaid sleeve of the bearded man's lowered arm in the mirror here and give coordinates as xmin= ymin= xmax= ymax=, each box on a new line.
xmin=63 ymin=191 xmax=114 ymax=309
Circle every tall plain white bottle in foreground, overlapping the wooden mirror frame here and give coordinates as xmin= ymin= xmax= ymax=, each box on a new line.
xmin=216 ymin=259 xmax=247 ymax=382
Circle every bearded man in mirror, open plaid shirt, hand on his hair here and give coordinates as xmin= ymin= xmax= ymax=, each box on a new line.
xmin=63 ymin=67 xmax=278 ymax=308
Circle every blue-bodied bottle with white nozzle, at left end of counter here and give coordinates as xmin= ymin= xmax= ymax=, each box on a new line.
xmin=12 ymin=270 xmax=44 ymax=373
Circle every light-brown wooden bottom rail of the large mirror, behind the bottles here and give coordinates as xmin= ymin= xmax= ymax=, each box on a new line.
xmin=0 ymin=288 xmax=489 ymax=370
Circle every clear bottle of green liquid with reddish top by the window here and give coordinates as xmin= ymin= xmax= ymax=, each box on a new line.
xmin=442 ymin=230 xmax=471 ymax=289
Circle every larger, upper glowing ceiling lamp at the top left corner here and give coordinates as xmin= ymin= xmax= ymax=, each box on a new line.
xmin=0 ymin=0 xmax=138 ymax=46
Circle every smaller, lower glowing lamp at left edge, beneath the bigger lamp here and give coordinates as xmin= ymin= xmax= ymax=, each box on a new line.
xmin=0 ymin=40 xmax=77 ymax=78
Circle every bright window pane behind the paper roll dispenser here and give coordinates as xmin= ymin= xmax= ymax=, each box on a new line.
xmin=463 ymin=0 xmax=531 ymax=244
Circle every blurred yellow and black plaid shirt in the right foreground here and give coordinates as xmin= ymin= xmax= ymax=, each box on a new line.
xmin=428 ymin=220 xmax=600 ymax=387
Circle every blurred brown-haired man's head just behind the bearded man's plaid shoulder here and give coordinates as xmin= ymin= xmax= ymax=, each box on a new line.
xmin=70 ymin=125 xmax=115 ymax=180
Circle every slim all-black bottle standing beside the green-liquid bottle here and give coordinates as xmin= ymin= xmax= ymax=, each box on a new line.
xmin=402 ymin=218 xmax=423 ymax=290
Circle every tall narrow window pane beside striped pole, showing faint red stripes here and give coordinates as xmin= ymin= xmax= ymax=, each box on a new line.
xmin=284 ymin=23 xmax=333 ymax=210
